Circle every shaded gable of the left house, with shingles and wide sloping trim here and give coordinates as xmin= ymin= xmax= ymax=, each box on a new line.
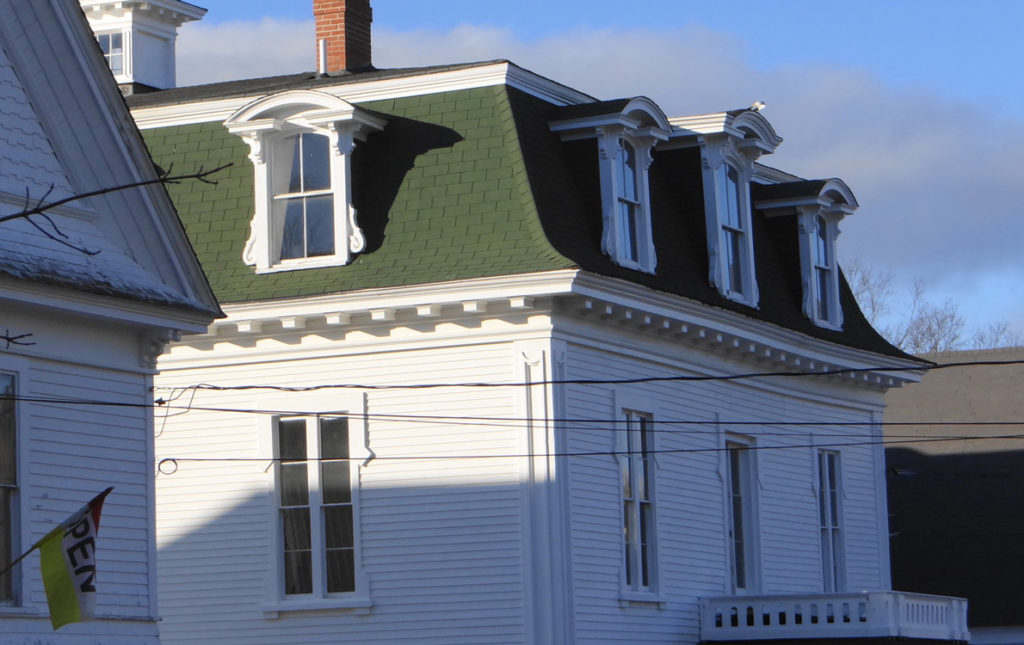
xmin=0 ymin=0 xmax=220 ymax=321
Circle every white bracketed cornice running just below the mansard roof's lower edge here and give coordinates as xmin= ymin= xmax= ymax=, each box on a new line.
xmin=182 ymin=269 xmax=922 ymax=389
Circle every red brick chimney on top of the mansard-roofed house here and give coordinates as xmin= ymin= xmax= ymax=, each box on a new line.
xmin=313 ymin=0 xmax=374 ymax=74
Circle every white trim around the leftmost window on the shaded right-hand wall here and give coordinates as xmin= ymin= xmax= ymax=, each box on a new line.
xmin=612 ymin=392 xmax=665 ymax=604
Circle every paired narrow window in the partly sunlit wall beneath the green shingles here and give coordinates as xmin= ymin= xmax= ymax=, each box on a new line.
xmin=274 ymin=416 xmax=357 ymax=598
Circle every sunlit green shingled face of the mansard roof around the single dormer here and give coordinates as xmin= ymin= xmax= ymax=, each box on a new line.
xmin=143 ymin=86 xmax=573 ymax=303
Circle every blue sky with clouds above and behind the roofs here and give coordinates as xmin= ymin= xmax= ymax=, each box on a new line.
xmin=178 ymin=0 xmax=1024 ymax=346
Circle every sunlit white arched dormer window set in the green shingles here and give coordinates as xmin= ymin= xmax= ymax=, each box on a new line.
xmin=224 ymin=90 xmax=384 ymax=273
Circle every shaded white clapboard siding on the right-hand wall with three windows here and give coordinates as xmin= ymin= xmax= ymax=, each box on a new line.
xmin=564 ymin=327 xmax=888 ymax=643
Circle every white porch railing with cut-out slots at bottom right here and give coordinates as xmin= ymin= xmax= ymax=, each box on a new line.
xmin=700 ymin=591 xmax=970 ymax=642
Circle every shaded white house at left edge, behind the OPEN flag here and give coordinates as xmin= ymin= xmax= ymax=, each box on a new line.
xmin=0 ymin=0 xmax=219 ymax=645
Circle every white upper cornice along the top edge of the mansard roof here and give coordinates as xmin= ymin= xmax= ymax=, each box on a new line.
xmin=132 ymin=60 xmax=594 ymax=130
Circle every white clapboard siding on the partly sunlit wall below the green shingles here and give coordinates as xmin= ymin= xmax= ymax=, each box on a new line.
xmin=157 ymin=343 xmax=525 ymax=644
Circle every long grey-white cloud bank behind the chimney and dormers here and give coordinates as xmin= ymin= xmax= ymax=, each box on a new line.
xmin=172 ymin=19 xmax=1024 ymax=332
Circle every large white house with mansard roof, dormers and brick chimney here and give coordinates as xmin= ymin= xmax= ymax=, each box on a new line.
xmin=92 ymin=0 xmax=967 ymax=645
